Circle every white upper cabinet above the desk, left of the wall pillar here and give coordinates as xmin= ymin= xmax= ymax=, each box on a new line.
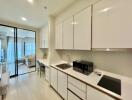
xmin=40 ymin=26 xmax=49 ymax=48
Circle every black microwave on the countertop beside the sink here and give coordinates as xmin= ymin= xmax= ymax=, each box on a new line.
xmin=73 ymin=61 xmax=93 ymax=75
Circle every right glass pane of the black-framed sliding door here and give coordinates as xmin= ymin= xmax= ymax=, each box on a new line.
xmin=17 ymin=29 xmax=36 ymax=74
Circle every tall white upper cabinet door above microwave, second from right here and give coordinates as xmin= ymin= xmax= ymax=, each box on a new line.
xmin=74 ymin=7 xmax=91 ymax=50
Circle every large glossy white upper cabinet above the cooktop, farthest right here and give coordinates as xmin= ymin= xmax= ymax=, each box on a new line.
xmin=92 ymin=0 xmax=132 ymax=48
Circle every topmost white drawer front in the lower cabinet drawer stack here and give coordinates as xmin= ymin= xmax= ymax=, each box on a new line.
xmin=68 ymin=76 xmax=86 ymax=92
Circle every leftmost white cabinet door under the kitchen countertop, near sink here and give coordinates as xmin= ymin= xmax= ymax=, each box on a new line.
xmin=50 ymin=67 xmax=57 ymax=91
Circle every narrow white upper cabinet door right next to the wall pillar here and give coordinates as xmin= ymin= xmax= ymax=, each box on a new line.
xmin=55 ymin=23 xmax=62 ymax=49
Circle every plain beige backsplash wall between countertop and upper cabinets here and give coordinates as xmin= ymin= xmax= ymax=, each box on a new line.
xmin=60 ymin=50 xmax=132 ymax=77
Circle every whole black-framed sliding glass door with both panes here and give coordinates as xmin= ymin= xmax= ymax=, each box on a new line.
xmin=0 ymin=25 xmax=36 ymax=76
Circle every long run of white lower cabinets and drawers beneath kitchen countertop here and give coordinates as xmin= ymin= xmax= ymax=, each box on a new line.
xmin=50 ymin=67 xmax=116 ymax=100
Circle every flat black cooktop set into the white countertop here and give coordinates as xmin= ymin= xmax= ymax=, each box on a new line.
xmin=98 ymin=75 xmax=121 ymax=95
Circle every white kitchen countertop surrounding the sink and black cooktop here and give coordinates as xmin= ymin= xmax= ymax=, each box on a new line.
xmin=51 ymin=61 xmax=132 ymax=100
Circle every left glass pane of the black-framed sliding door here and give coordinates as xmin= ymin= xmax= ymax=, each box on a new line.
xmin=0 ymin=26 xmax=16 ymax=76
